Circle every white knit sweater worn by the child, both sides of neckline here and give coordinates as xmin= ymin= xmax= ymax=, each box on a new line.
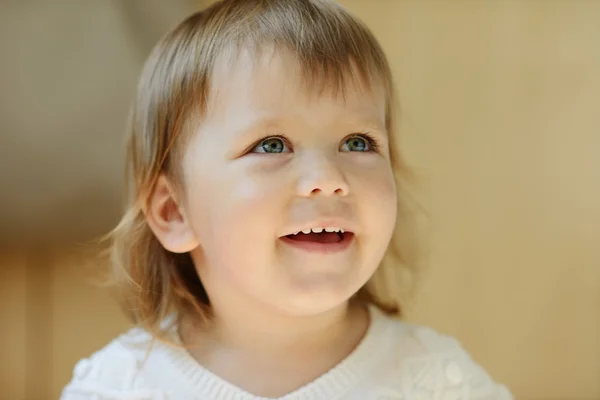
xmin=61 ymin=307 xmax=513 ymax=400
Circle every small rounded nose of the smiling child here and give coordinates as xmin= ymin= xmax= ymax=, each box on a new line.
xmin=298 ymin=156 xmax=349 ymax=197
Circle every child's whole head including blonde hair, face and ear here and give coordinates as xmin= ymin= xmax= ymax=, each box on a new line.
xmin=112 ymin=0 xmax=418 ymax=336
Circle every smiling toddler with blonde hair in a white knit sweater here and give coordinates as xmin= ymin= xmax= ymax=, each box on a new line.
xmin=61 ymin=0 xmax=512 ymax=400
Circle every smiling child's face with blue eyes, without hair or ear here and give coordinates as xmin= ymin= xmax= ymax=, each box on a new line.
xmin=183 ymin=48 xmax=397 ymax=314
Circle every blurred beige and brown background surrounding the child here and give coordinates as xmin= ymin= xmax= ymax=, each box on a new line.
xmin=0 ymin=0 xmax=600 ymax=400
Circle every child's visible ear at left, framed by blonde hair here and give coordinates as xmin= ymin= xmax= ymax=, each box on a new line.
xmin=145 ymin=175 xmax=199 ymax=253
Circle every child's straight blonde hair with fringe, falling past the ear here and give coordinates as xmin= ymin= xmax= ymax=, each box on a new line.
xmin=108 ymin=0 xmax=414 ymax=338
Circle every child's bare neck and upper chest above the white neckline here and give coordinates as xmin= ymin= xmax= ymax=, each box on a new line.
xmin=180 ymin=303 xmax=369 ymax=397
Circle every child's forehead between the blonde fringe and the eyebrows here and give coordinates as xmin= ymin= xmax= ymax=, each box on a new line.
xmin=206 ymin=46 xmax=386 ymax=123
